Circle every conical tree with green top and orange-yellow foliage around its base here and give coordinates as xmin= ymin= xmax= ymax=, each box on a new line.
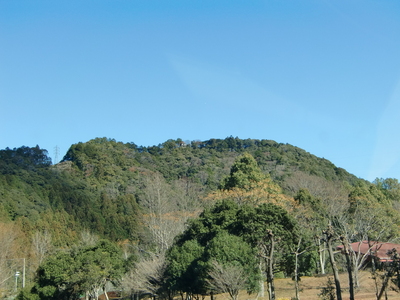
xmin=204 ymin=153 xmax=296 ymax=211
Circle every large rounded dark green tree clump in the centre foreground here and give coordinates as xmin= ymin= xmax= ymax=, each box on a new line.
xmin=167 ymin=200 xmax=299 ymax=299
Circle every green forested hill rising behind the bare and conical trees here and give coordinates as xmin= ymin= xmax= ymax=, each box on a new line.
xmin=0 ymin=137 xmax=359 ymax=245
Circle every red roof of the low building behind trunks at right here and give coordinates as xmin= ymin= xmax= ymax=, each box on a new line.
xmin=337 ymin=241 xmax=400 ymax=261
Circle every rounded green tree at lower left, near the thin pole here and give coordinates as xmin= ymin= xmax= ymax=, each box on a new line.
xmin=19 ymin=240 xmax=124 ymax=300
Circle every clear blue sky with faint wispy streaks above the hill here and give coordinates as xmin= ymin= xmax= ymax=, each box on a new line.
xmin=0 ymin=0 xmax=400 ymax=180
